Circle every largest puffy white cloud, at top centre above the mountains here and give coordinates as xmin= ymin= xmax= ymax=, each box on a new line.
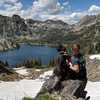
xmin=22 ymin=0 xmax=63 ymax=19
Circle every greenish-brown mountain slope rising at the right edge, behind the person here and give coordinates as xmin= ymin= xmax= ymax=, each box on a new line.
xmin=73 ymin=14 xmax=100 ymax=53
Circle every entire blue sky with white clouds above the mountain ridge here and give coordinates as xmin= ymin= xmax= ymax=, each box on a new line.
xmin=0 ymin=0 xmax=100 ymax=24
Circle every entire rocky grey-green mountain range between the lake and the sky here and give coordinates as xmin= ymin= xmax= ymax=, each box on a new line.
xmin=0 ymin=14 xmax=100 ymax=53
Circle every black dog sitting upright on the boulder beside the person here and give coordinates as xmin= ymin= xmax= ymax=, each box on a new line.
xmin=54 ymin=45 xmax=71 ymax=80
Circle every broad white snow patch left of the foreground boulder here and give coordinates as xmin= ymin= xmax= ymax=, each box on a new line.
xmin=0 ymin=69 xmax=53 ymax=100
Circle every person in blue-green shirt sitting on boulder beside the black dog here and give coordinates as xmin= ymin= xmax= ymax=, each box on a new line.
xmin=69 ymin=44 xmax=87 ymax=80
